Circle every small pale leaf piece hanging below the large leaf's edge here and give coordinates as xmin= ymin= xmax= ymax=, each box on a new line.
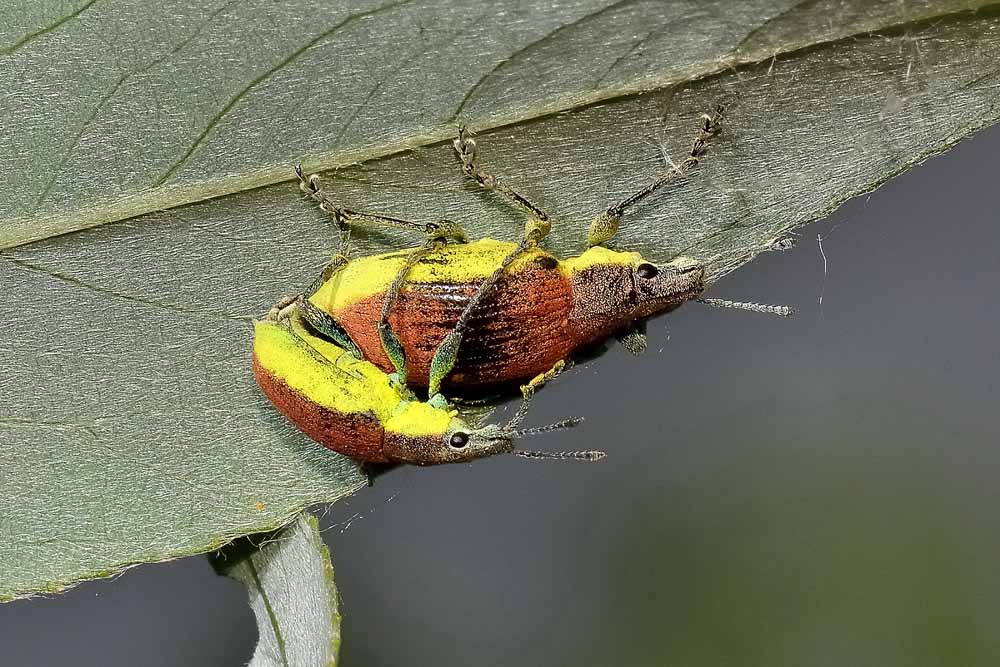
xmin=211 ymin=512 xmax=340 ymax=667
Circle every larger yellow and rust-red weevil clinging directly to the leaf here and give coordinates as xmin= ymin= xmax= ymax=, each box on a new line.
xmin=296 ymin=106 xmax=790 ymax=396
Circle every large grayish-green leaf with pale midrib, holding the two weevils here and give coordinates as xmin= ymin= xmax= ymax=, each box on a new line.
xmin=0 ymin=0 xmax=1000 ymax=599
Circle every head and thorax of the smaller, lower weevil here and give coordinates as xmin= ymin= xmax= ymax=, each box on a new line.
xmin=383 ymin=402 xmax=514 ymax=465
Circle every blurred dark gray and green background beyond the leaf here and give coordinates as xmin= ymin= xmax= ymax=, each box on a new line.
xmin=0 ymin=121 xmax=1000 ymax=667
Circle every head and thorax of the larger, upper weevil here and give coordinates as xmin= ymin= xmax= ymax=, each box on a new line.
xmin=562 ymin=246 xmax=705 ymax=342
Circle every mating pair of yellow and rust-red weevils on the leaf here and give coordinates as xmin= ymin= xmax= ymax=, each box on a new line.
xmin=254 ymin=107 xmax=790 ymax=464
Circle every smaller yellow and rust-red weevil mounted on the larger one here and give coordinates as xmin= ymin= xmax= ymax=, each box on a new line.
xmin=253 ymin=302 xmax=604 ymax=465
